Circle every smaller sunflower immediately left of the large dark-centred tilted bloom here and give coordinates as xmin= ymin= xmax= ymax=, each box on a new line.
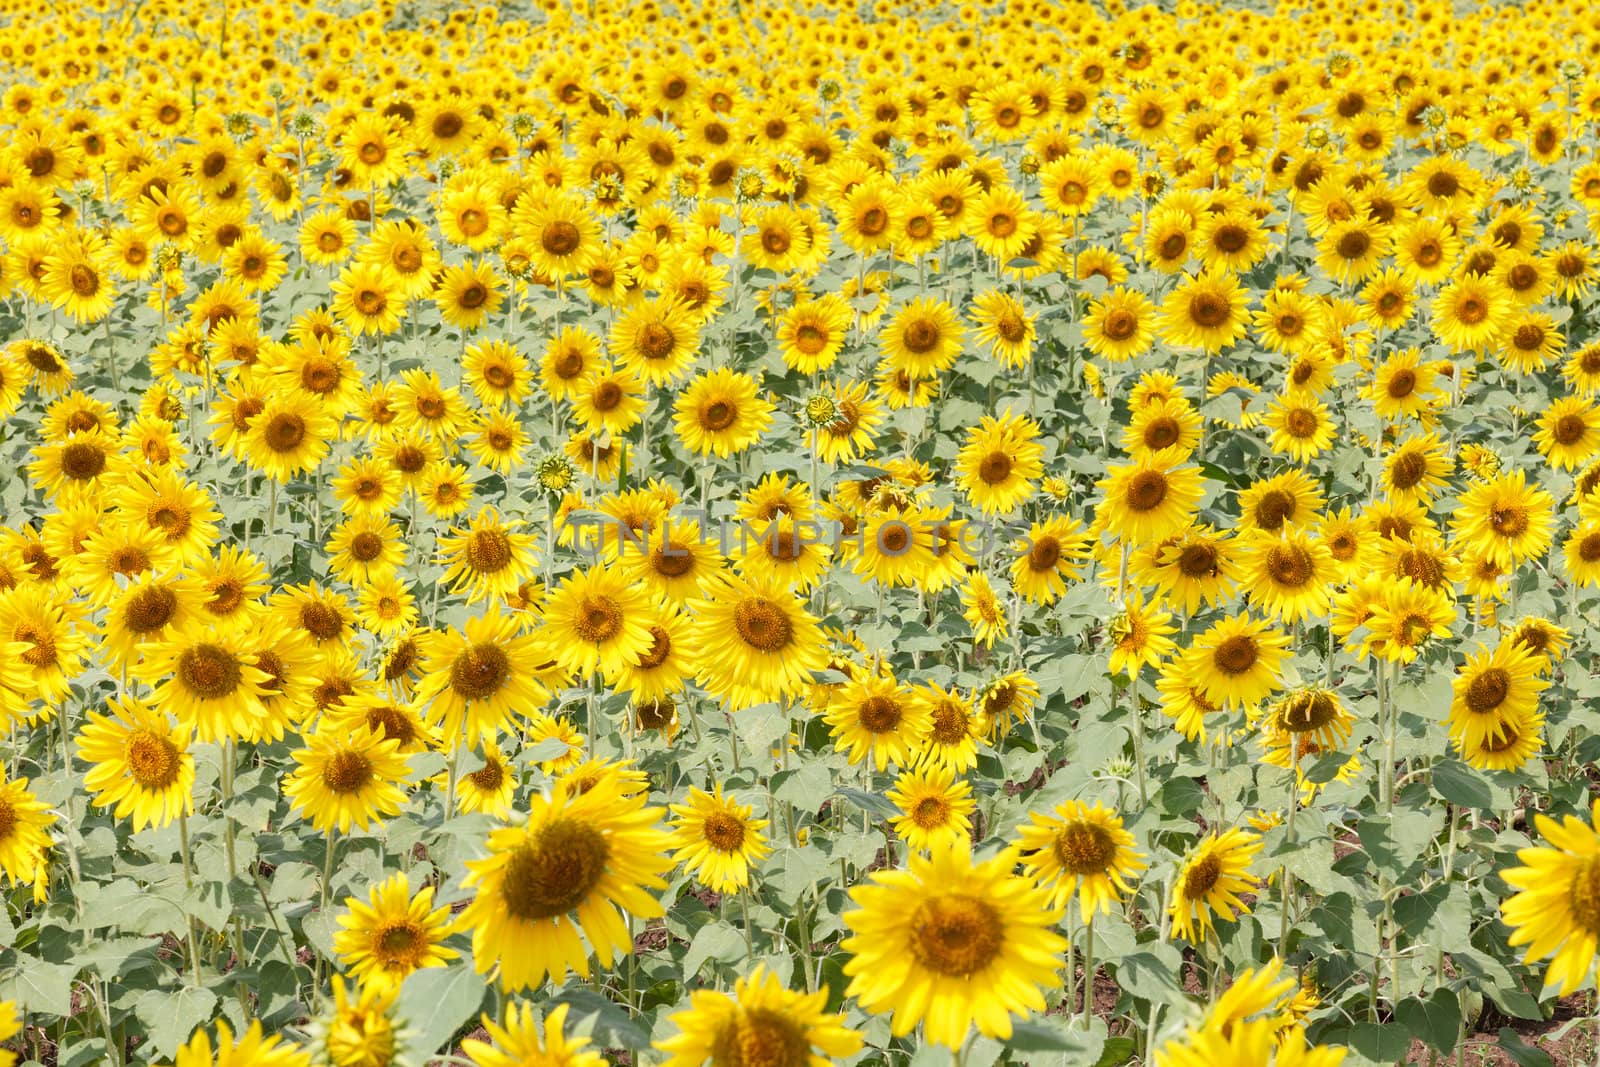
xmin=333 ymin=872 xmax=461 ymax=990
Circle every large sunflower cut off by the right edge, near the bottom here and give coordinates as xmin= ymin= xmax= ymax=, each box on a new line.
xmin=1499 ymin=800 xmax=1600 ymax=997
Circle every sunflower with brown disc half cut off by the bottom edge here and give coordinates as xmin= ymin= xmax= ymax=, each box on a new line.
xmin=652 ymin=963 xmax=862 ymax=1067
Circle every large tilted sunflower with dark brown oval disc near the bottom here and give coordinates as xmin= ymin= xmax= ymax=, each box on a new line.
xmin=459 ymin=767 xmax=674 ymax=992
